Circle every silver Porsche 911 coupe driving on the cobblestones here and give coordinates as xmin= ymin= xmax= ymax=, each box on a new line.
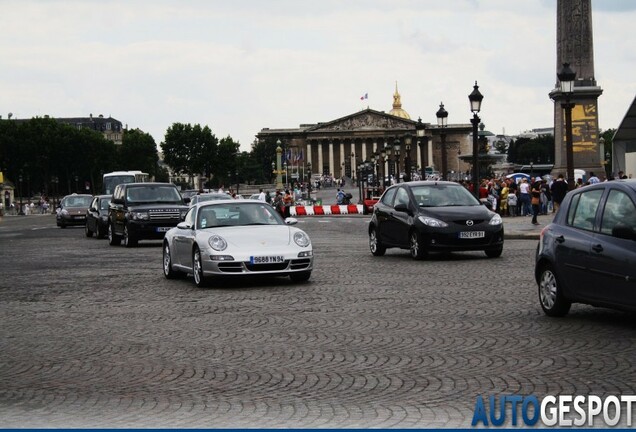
xmin=163 ymin=199 xmax=314 ymax=286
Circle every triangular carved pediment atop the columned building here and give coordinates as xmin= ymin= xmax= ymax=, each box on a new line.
xmin=307 ymin=109 xmax=415 ymax=133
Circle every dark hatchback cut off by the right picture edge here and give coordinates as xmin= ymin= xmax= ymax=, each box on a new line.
xmin=535 ymin=180 xmax=636 ymax=316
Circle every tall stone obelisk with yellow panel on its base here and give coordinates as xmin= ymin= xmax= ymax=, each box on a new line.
xmin=550 ymin=0 xmax=605 ymax=178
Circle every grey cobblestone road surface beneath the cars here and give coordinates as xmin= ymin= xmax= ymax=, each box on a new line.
xmin=0 ymin=216 xmax=636 ymax=428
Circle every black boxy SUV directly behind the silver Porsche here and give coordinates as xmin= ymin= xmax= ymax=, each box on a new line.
xmin=108 ymin=183 xmax=190 ymax=247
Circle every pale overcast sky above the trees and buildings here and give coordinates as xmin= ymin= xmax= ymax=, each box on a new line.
xmin=0 ymin=0 xmax=636 ymax=150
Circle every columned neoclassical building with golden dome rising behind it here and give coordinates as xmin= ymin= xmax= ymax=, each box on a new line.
xmin=256 ymin=84 xmax=472 ymax=179
